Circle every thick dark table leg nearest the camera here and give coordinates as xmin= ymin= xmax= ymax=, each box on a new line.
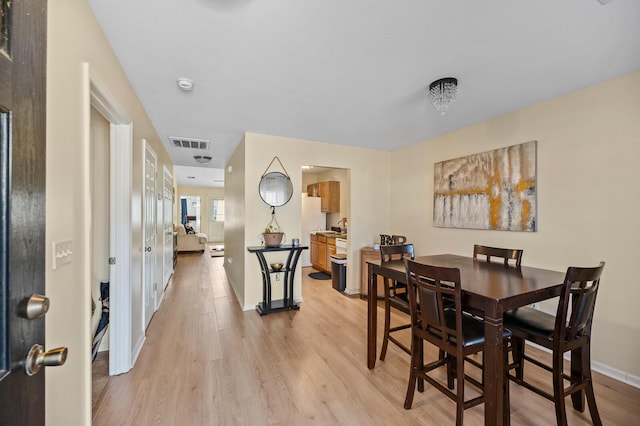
xmin=484 ymin=311 xmax=509 ymax=426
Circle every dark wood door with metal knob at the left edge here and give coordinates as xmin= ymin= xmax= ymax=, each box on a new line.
xmin=0 ymin=0 xmax=47 ymax=425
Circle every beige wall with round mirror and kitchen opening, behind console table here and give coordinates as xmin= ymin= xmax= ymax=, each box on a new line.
xmin=225 ymin=133 xmax=389 ymax=309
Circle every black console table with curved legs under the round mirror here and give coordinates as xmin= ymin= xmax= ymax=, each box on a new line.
xmin=247 ymin=245 xmax=309 ymax=315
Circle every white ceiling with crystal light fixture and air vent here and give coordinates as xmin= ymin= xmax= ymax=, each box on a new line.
xmin=88 ymin=0 xmax=640 ymax=186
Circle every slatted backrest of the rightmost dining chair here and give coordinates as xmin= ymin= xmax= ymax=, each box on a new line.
xmin=556 ymin=262 xmax=604 ymax=342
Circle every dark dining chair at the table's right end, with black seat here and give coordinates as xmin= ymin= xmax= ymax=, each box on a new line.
xmin=504 ymin=262 xmax=604 ymax=425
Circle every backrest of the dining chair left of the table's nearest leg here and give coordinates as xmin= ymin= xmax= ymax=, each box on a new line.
xmin=405 ymin=259 xmax=462 ymax=345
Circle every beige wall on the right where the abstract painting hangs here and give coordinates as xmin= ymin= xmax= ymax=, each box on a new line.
xmin=390 ymin=72 xmax=640 ymax=385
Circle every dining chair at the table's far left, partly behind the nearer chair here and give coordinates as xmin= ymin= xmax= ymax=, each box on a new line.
xmin=380 ymin=244 xmax=415 ymax=361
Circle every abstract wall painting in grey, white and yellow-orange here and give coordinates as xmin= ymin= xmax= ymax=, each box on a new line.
xmin=433 ymin=141 xmax=536 ymax=232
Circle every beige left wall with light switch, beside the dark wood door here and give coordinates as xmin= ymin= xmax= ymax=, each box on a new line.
xmin=45 ymin=0 xmax=173 ymax=425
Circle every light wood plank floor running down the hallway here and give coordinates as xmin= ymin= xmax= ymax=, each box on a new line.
xmin=94 ymin=251 xmax=640 ymax=426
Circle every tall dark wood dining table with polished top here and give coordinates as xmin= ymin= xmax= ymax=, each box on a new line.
xmin=367 ymin=254 xmax=565 ymax=425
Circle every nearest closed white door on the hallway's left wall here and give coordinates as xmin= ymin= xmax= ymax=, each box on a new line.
xmin=142 ymin=141 xmax=157 ymax=328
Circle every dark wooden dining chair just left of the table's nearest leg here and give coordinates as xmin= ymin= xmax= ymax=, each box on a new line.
xmin=404 ymin=259 xmax=508 ymax=425
